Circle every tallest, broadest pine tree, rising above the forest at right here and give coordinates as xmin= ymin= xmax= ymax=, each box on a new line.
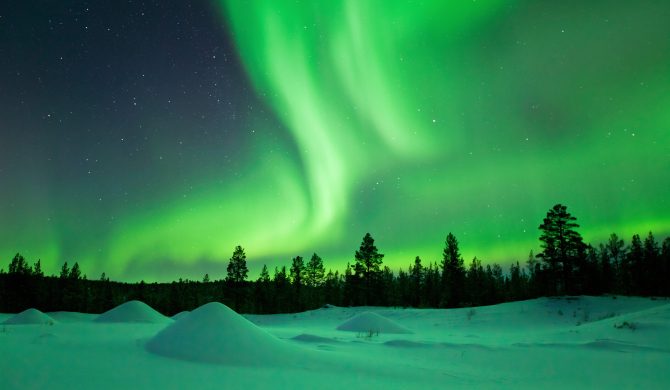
xmin=537 ymin=204 xmax=586 ymax=294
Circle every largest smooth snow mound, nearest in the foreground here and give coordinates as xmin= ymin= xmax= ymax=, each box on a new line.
xmin=146 ymin=302 xmax=294 ymax=366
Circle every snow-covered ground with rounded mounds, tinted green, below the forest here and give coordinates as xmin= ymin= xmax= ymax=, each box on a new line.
xmin=0 ymin=297 xmax=670 ymax=390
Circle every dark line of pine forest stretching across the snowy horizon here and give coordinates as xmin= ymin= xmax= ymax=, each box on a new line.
xmin=0 ymin=204 xmax=670 ymax=315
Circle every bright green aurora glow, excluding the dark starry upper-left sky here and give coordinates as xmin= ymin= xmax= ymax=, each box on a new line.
xmin=0 ymin=0 xmax=670 ymax=280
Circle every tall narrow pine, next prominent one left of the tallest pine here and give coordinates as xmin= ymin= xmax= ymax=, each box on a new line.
xmin=442 ymin=233 xmax=465 ymax=307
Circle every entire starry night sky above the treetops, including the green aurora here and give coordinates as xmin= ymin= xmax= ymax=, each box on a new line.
xmin=0 ymin=0 xmax=670 ymax=281
